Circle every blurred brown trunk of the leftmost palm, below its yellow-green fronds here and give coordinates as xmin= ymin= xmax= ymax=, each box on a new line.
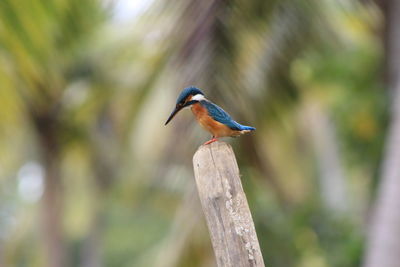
xmin=33 ymin=112 xmax=66 ymax=267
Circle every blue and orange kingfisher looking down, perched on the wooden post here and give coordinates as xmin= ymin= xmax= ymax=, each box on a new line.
xmin=165 ymin=86 xmax=256 ymax=145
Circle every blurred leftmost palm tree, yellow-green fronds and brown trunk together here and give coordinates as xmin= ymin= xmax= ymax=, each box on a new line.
xmin=0 ymin=0 xmax=104 ymax=267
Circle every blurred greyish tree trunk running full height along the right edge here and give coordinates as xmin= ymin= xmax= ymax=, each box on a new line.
xmin=364 ymin=0 xmax=400 ymax=267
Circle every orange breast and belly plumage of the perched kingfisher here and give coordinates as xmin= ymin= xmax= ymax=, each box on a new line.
xmin=191 ymin=103 xmax=239 ymax=137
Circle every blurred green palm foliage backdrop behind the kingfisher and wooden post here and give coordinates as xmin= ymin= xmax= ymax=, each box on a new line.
xmin=0 ymin=0 xmax=396 ymax=267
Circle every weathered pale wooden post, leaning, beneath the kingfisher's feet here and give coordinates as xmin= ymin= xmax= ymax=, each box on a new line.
xmin=193 ymin=141 xmax=264 ymax=267
